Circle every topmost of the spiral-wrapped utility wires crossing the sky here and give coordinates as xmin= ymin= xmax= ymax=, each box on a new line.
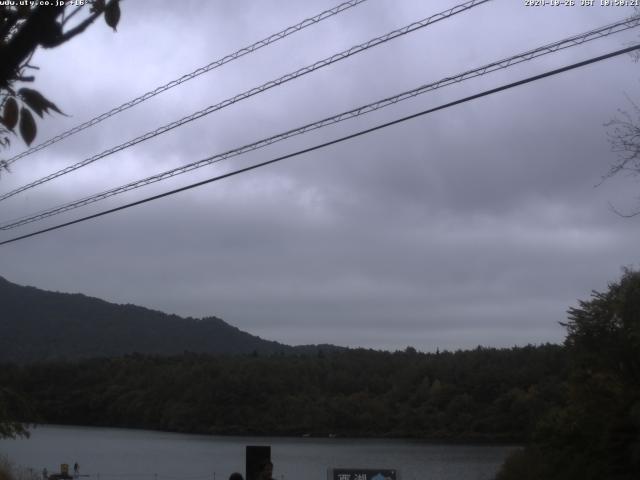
xmin=5 ymin=0 xmax=367 ymax=165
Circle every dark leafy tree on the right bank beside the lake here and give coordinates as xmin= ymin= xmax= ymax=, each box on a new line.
xmin=499 ymin=270 xmax=640 ymax=480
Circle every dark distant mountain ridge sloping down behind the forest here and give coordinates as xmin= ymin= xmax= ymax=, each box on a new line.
xmin=0 ymin=277 xmax=336 ymax=363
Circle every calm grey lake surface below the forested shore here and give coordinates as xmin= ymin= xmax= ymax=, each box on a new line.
xmin=0 ymin=425 xmax=516 ymax=480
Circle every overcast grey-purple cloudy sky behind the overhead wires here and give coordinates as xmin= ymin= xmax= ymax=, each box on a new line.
xmin=0 ymin=0 xmax=640 ymax=351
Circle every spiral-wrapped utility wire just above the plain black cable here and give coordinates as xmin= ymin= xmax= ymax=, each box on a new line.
xmin=0 ymin=16 xmax=640 ymax=230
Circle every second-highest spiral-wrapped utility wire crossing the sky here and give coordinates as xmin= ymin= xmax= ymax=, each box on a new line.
xmin=0 ymin=0 xmax=491 ymax=201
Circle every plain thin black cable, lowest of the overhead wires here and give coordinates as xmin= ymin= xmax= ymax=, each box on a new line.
xmin=0 ymin=45 xmax=640 ymax=246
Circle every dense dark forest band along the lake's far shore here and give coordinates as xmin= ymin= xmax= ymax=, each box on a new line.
xmin=0 ymin=345 xmax=567 ymax=441
